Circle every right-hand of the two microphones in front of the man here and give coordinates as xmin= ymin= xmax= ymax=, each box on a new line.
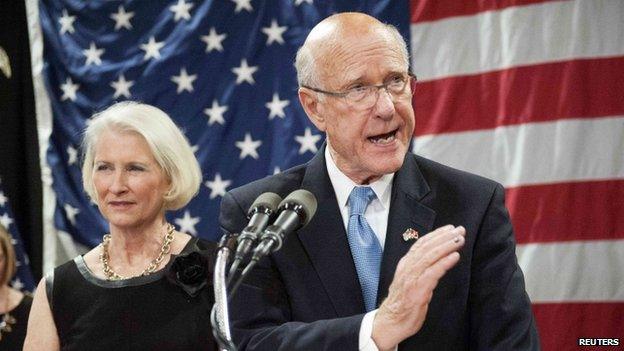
xmin=252 ymin=189 xmax=317 ymax=261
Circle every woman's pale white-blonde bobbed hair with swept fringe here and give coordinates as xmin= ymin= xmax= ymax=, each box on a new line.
xmin=82 ymin=101 xmax=202 ymax=210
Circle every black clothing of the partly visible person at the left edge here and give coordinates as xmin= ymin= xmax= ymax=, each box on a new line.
xmin=0 ymin=294 xmax=32 ymax=351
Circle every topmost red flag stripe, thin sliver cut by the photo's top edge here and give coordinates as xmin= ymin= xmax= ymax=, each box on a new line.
xmin=410 ymin=0 xmax=554 ymax=23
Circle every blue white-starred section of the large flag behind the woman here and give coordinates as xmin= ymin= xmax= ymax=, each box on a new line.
xmin=29 ymin=0 xmax=409 ymax=270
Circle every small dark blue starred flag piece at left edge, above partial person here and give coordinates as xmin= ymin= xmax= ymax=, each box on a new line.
xmin=0 ymin=179 xmax=35 ymax=291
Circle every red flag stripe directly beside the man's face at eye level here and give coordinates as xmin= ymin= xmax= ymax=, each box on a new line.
xmin=414 ymin=57 xmax=624 ymax=135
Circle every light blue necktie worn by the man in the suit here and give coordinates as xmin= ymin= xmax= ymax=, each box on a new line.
xmin=347 ymin=186 xmax=382 ymax=312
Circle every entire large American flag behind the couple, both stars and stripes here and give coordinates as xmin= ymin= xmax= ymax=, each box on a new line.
xmin=27 ymin=0 xmax=624 ymax=350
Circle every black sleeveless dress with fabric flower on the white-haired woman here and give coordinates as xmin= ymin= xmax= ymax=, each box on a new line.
xmin=46 ymin=238 xmax=217 ymax=351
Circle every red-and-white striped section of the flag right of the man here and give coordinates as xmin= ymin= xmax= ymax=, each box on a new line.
xmin=411 ymin=0 xmax=624 ymax=350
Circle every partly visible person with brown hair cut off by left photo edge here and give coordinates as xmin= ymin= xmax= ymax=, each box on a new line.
xmin=0 ymin=225 xmax=32 ymax=350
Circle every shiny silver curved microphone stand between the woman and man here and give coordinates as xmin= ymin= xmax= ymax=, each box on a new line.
xmin=210 ymin=234 xmax=238 ymax=351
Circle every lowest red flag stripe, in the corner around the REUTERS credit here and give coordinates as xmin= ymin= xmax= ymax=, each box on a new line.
xmin=533 ymin=302 xmax=624 ymax=351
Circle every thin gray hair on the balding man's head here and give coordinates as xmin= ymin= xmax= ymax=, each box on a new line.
xmin=295 ymin=24 xmax=409 ymax=88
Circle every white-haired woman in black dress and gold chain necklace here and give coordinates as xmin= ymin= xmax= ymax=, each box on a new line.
xmin=24 ymin=102 xmax=216 ymax=351
